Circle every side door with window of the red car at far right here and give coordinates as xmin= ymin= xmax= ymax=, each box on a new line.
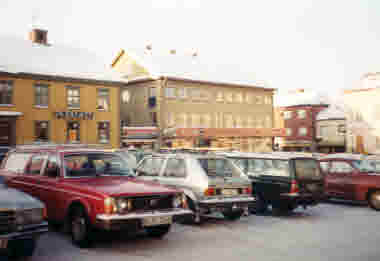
xmin=326 ymin=160 xmax=353 ymax=198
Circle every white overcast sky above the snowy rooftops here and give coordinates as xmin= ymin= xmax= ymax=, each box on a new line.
xmin=0 ymin=0 xmax=380 ymax=91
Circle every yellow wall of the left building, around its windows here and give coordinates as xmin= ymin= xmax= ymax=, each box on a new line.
xmin=0 ymin=77 xmax=120 ymax=147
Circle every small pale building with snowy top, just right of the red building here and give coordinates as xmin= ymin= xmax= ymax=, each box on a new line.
xmin=316 ymin=105 xmax=346 ymax=153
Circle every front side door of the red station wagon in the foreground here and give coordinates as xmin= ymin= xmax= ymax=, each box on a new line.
xmin=35 ymin=153 xmax=64 ymax=220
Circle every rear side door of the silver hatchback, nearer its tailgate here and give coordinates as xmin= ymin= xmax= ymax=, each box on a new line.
xmin=160 ymin=157 xmax=188 ymax=189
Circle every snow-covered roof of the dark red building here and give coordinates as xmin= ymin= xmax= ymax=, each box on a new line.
xmin=274 ymin=90 xmax=328 ymax=107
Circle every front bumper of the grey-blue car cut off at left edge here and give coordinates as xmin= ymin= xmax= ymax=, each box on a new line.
xmin=0 ymin=222 xmax=49 ymax=241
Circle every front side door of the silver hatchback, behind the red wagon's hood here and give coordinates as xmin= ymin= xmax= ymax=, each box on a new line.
xmin=136 ymin=157 xmax=164 ymax=183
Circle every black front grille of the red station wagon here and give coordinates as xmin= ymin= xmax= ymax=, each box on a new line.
xmin=132 ymin=195 xmax=173 ymax=211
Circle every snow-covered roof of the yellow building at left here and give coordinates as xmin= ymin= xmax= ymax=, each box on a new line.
xmin=0 ymin=35 xmax=127 ymax=83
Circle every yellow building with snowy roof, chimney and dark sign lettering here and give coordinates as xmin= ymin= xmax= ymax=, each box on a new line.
xmin=0 ymin=29 xmax=127 ymax=147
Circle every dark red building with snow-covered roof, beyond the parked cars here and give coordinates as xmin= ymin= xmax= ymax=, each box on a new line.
xmin=275 ymin=89 xmax=328 ymax=152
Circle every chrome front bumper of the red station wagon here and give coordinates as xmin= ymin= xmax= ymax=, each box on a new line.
xmin=96 ymin=208 xmax=193 ymax=230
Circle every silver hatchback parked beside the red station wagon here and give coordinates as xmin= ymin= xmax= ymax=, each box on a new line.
xmin=136 ymin=154 xmax=255 ymax=223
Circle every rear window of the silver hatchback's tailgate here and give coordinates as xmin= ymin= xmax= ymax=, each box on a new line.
xmin=198 ymin=159 xmax=233 ymax=177
